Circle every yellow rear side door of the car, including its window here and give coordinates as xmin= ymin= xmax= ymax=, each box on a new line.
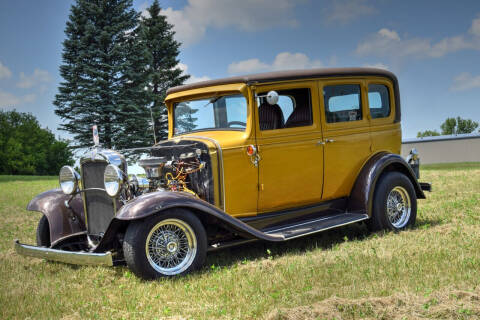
xmin=319 ymin=79 xmax=372 ymax=200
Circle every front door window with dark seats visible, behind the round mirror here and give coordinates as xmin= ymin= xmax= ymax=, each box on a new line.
xmin=258 ymin=88 xmax=313 ymax=130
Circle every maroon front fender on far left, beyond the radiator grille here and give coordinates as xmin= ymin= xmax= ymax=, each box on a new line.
xmin=27 ymin=189 xmax=86 ymax=246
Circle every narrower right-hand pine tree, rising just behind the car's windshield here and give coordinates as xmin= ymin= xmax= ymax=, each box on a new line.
xmin=138 ymin=0 xmax=190 ymax=141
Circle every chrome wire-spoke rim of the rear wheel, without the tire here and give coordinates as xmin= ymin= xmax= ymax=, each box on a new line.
xmin=387 ymin=186 xmax=412 ymax=229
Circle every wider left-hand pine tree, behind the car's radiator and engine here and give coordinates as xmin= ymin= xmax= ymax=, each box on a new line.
xmin=53 ymin=0 xmax=145 ymax=148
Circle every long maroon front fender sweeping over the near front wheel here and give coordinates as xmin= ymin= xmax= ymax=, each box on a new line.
xmin=94 ymin=191 xmax=284 ymax=252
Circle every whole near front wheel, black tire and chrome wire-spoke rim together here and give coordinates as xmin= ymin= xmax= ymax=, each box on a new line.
xmin=123 ymin=209 xmax=207 ymax=279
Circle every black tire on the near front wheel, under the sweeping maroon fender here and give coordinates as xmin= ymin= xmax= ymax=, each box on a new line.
xmin=123 ymin=209 xmax=207 ymax=279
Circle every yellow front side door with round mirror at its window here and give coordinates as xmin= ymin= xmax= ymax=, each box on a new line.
xmin=255 ymin=81 xmax=323 ymax=212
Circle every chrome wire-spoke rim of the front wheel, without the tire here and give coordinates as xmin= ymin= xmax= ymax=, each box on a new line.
xmin=145 ymin=219 xmax=197 ymax=275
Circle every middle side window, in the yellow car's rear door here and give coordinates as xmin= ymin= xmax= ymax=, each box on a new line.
xmin=323 ymin=84 xmax=362 ymax=123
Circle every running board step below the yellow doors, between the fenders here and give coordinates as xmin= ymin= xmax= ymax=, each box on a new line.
xmin=265 ymin=213 xmax=368 ymax=240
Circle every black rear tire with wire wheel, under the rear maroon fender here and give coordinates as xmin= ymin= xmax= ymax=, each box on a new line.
xmin=367 ymin=172 xmax=417 ymax=231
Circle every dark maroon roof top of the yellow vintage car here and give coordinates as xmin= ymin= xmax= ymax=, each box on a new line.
xmin=167 ymin=68 xmax=398 ymax=94
